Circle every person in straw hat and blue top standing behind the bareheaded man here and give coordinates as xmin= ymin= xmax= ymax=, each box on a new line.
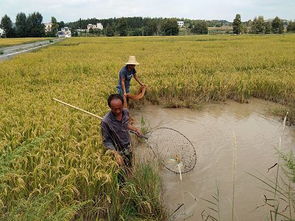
xmin=117 ymin=56 xmax=145 ymax=99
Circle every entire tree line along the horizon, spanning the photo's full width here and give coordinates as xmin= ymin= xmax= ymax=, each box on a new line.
xmin=0 ymin=12 xmax=295 ymax=37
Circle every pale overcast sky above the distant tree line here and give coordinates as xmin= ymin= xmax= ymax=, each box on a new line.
xmin=0 ymin=0 xmax=295 ymax=22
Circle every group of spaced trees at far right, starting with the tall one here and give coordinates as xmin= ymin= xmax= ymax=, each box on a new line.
xmin=232 ymin=14 xmax=295 ymax=34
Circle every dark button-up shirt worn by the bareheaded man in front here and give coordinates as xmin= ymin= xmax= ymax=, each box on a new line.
xmin=101 ymin=109 xmax=130 ymax=151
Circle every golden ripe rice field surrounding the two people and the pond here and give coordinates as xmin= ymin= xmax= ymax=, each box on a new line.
xmin=0 ymin=35 xmax=295 ymax=220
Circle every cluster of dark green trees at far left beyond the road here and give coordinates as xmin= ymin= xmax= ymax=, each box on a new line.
xmin=0 ymin=12 xmax=64 ymax=38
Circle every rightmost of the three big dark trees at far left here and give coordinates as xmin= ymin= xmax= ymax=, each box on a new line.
xmin=27 ymin=12 xmax=45 ymax=37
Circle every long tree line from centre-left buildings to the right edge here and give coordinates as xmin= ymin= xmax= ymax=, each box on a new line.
xmin=67 ymin=14 xmax=295 ymax=36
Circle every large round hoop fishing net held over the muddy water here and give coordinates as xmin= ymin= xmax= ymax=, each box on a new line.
xmin=145 ymin=127 xmax=197 ymax=173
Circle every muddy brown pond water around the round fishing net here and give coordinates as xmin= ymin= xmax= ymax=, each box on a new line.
xmin=134 ymin=99 xmax=295 ymax=221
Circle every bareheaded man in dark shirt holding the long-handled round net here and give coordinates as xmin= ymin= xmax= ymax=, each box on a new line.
xmin=101 ymin=94 xmax=142 ymax=168
